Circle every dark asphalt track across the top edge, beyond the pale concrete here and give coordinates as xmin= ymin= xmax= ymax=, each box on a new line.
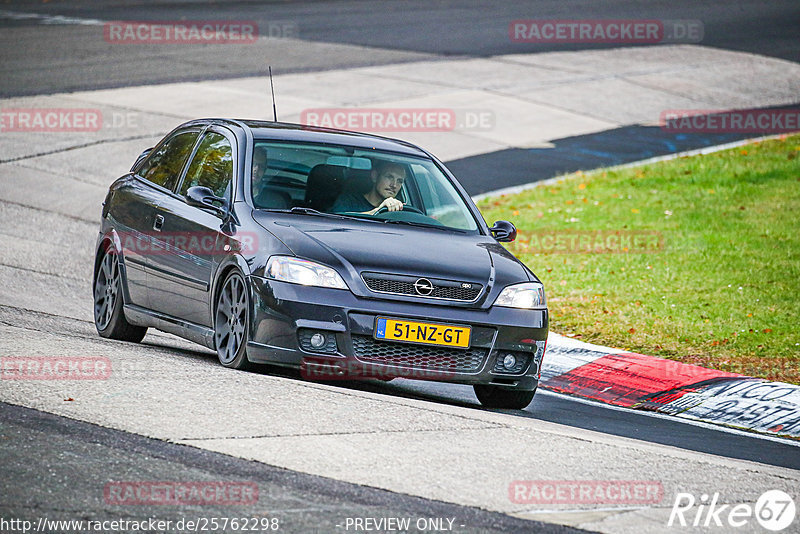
xmin=0 ymin=0 xmax=800 ymax=96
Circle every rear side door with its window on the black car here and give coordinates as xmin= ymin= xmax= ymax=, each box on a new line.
xmin=116 ymin=129 xmax=200 ymax=308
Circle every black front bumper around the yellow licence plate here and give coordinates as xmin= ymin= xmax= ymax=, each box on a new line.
xmin=247 ymin=276 xmax=548 ymax=390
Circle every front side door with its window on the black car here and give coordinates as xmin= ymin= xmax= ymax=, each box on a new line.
xmin=150 ymin=128 xmax=236 ymax=326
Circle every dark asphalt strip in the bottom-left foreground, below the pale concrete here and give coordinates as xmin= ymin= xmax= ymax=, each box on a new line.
xmin=0 ymin=405 xmax=580 ymax=534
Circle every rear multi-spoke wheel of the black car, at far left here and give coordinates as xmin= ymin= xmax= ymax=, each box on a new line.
xmin=93 ymin=247 xmax=147 ymax=343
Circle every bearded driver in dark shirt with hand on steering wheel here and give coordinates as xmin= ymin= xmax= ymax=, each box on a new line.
xmin=331 ymin=161 xmax=406 ymax=215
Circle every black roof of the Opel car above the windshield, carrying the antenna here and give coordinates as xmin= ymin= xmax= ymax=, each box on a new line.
xmin=182 ymin=118 xmax=430 ymax=157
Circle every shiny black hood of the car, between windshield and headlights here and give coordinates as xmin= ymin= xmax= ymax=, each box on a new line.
xmin=254 ymin=211 xmax=532 ymax=304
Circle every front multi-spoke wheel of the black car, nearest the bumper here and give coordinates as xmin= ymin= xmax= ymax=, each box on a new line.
xmin=214 ymin=271 xmax=253 ymax=370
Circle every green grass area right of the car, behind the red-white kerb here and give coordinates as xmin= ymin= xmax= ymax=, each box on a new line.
xmin=478 ymin=135 xmax=800 ymax=383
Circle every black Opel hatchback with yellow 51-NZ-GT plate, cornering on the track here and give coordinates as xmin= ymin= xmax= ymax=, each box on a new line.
xmin=93 ymin=119 xmax=548 ymax=408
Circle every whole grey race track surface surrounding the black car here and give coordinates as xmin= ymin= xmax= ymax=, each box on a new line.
xmin=0 ymin=0 xmax=800 ymax=533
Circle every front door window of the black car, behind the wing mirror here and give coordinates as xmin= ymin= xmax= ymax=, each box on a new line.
xmin=180 ymin=132 xmax=233 ymax=200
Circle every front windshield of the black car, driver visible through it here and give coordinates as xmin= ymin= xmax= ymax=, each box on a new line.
xmin=250 ymin=139 xmax=478 ymax=232
